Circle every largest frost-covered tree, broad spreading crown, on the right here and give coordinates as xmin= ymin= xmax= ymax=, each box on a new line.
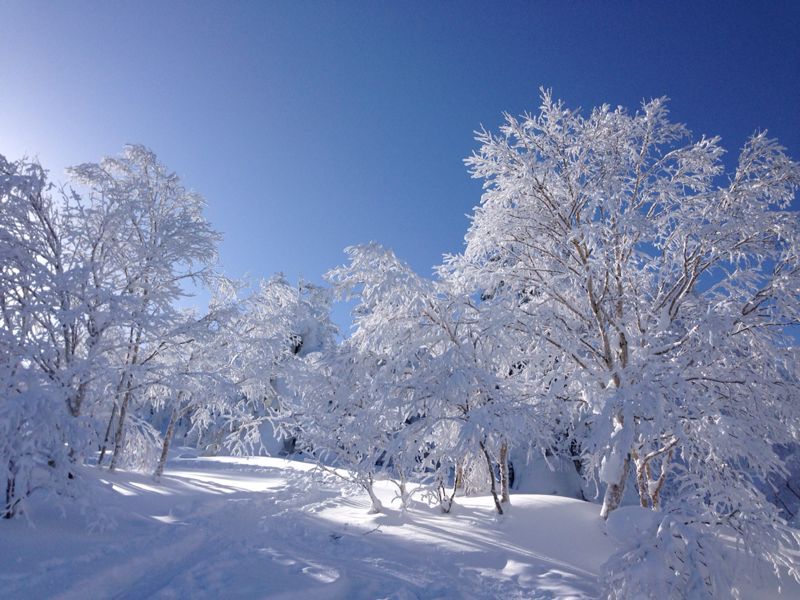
xmin=446 ymin=92 xmax=800 ymax=593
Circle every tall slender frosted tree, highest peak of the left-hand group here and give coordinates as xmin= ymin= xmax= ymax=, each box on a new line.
xmin=69 ymin=145 xmax=219 ymax=469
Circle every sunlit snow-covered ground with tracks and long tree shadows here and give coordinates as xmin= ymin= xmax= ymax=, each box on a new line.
xmin=0 ymin=455 xmax=790 ymax=600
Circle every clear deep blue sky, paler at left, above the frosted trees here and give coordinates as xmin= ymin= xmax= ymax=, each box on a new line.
xmin=0 ymin=0 xmax=800 ymax=322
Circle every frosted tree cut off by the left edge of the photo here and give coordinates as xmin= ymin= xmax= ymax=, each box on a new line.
xmin=0 ymin=156 xmax=113 ymax=516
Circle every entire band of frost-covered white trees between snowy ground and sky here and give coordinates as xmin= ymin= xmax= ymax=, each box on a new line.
xmin=0 ymin=91 xmax=800 ymax=598
